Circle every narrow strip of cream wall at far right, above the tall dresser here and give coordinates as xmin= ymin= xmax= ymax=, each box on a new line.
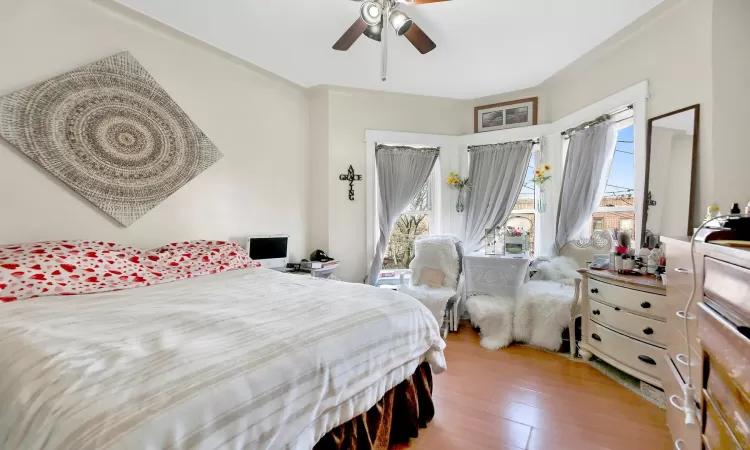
xmin=713 ymin=0 xmax=750 ymax=208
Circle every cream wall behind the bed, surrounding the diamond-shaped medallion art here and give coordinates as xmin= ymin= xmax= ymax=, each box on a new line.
xmin=0 ymin=0 xmax=309 ymax=257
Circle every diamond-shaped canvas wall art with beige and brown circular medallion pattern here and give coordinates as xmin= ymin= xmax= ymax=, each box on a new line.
xmin=0 ymin=52 xmax=223 ymax=226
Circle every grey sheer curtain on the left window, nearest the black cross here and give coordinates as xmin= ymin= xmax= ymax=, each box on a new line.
xmin=367 ymin=145 xmax=439 ymax=285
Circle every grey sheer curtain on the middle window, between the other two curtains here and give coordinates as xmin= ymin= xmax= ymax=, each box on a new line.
xmin=463 ymin=141 xmax=533 ymax=254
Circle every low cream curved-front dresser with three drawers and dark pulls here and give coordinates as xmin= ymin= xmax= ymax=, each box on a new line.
xmin=579 ymin=269 xmax=668 ymax=387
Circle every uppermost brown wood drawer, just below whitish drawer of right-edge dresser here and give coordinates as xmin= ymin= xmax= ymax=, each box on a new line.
xmin=698 ymin=303 xmax=750 ymax=397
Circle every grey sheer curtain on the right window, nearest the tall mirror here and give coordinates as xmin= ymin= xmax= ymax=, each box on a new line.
xmin=552 ymin=119 xmax=617 ymax=255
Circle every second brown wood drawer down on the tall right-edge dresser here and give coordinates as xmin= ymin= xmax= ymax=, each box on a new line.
xmin=706 ymin=358 xmax=750 ymax=448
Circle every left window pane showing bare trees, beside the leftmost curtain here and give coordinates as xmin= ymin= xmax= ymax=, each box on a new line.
xmin=383 ymin=173 xmax=434 ymax=270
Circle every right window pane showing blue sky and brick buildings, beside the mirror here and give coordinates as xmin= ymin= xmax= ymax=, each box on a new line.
xmin=591 ymin=121 xmax=636 ymax=245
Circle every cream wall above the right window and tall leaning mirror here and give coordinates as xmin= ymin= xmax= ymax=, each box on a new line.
xmin=472 ymin=0 xmax=716 ymax=227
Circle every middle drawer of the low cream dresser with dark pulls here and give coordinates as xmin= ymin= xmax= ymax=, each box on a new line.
xmin=589 ymin=298 xmax=667 ymax=347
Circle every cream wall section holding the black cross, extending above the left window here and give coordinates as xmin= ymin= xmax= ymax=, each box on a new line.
xmin=327 ymin=88 xmax=471 ymax=281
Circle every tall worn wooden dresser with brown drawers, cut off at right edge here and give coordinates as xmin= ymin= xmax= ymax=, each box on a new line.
xmin=662 ymin=238 xmax=750 ymax=450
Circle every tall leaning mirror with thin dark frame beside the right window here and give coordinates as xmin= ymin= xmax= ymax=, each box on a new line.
xmin=643 ymin=105 xmax=700 ymax=236
